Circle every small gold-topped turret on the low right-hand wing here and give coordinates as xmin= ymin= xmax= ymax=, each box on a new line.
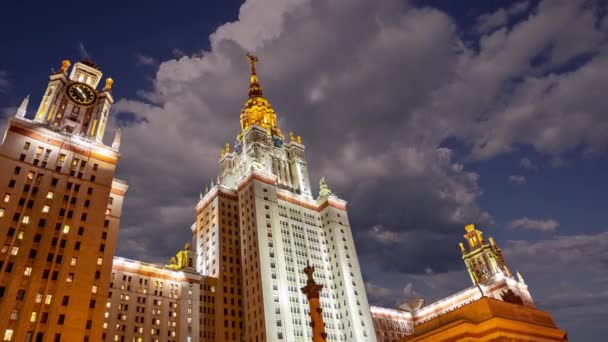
xmin=459 ymin=224 xmax=511 ymax=285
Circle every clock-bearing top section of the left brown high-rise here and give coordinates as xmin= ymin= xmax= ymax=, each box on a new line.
xmin=34 ymin=59 xmax=114 ymax=143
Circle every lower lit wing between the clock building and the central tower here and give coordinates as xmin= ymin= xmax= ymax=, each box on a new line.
xmin=103 ymin=257 xmax=218 ymax=342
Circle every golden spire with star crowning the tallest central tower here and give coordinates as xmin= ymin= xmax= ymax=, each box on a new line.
xmin=239 ymin=53 xmax=284 ymax=140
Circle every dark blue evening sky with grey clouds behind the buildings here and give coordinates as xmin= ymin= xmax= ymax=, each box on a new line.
xmin=0 ymin=0 xmax=608 ymax=341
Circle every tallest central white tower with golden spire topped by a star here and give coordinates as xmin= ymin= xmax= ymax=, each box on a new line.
xmin=192 ymin=54 xmax=376 ymax=342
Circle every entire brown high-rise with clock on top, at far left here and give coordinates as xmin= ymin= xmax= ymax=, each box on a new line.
xmin=0 ymin=61 xmax=127 ymax=341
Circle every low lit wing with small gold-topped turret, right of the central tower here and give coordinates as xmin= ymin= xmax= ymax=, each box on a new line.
xmin=371 ymin=224 xmax=550 ymax=342
